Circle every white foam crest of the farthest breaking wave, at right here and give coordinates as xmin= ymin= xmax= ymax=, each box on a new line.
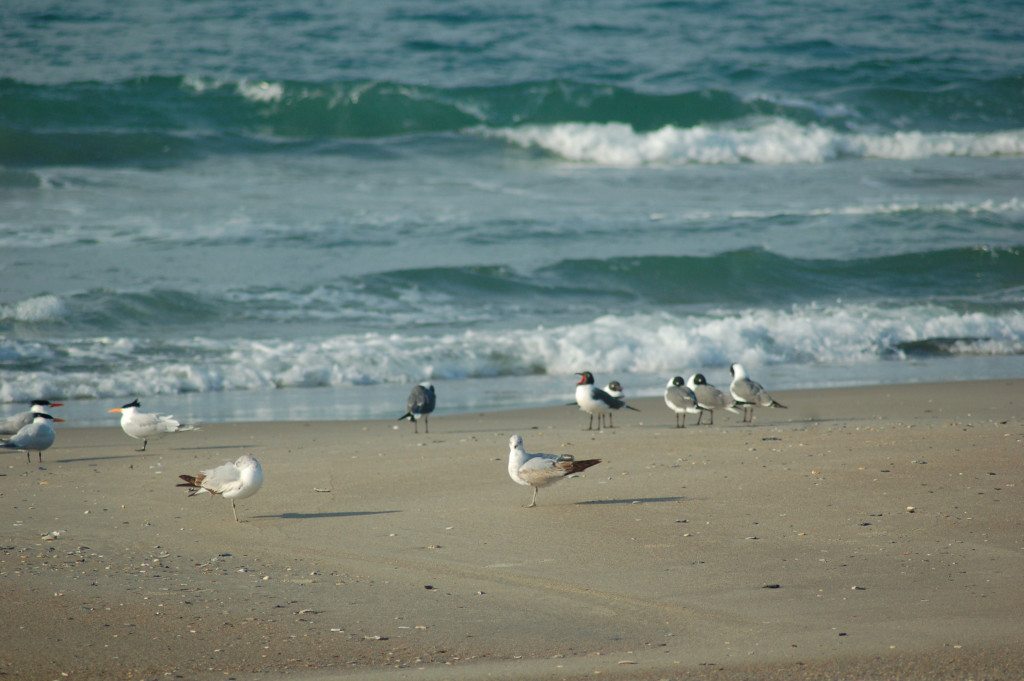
xmin=476 ymin=119 xmax=1024 ymax=168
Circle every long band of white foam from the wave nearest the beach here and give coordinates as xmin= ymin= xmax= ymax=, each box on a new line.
xmin=0 ymin=305 xmax=1024 ymax=401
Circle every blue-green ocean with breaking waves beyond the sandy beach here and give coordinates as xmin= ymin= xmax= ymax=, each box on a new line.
xmin=0 ymin=0 xmax=1024 ymax=425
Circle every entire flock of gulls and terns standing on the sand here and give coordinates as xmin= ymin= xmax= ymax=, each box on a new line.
xmin=0 ymin=365 xmax=785 ymax=521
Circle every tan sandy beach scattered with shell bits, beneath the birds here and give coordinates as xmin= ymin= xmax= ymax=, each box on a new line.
xmin=0 ymin=380 xmax=1024 ymax=680
